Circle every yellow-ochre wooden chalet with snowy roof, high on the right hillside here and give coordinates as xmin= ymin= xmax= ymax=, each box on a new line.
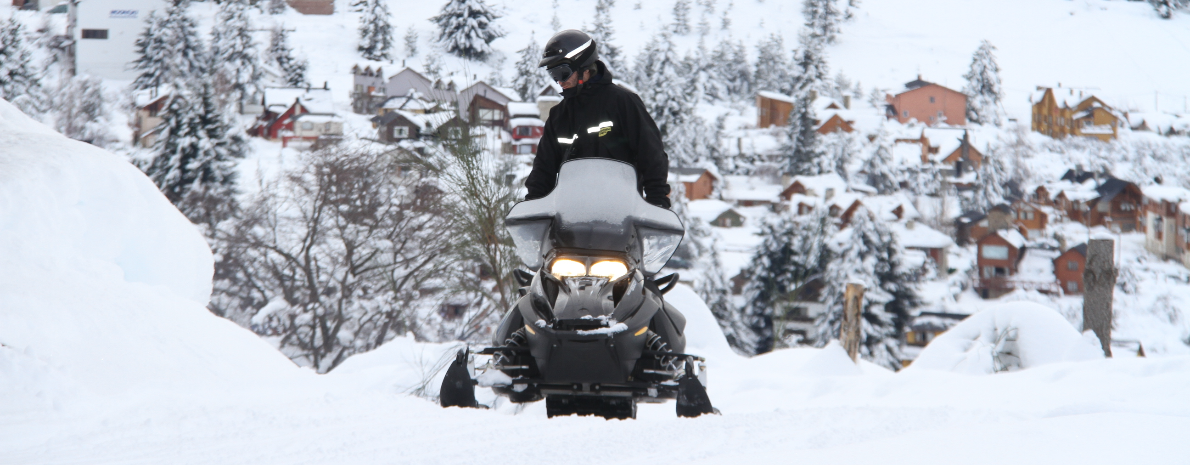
xmin=1029 ymin=86 xmax=1125 ymax=142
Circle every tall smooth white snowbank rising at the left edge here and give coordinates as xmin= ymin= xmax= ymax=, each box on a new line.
xmin=0 ymin=100 xmax=300 ymax=411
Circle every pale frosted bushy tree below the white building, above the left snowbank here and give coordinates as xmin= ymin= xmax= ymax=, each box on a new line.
xmin=54 ymin=76 xmax=115 ymax=146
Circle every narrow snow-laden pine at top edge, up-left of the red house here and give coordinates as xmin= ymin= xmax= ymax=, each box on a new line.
xmin=211 ymin=0 xmax=263 ymax=102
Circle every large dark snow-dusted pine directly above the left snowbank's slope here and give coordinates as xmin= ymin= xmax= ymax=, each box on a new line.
xmin=145 ymin=82 xmax=248 ymax=225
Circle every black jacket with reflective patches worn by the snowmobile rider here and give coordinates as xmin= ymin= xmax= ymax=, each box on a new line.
xmin=525 ymin=62 xmax=670 ymax=208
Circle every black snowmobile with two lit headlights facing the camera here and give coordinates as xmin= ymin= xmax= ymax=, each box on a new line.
xmin=439 ymin=158 xmax=716 ymax=419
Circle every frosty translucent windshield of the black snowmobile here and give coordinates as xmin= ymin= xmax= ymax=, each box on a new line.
xmin=505 ymin=158 xmax=685 ymax=275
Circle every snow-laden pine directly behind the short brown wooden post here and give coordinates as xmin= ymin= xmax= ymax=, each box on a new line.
xmin=816 ymin=207 xmax=920 ymax=370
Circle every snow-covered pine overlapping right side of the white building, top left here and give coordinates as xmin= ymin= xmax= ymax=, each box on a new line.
xmin=131 ymin=0 xmax=209 ymax=89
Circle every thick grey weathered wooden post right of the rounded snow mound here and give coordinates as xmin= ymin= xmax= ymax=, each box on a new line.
xmin=1083 ymin=239 xmax=1119 ymax=357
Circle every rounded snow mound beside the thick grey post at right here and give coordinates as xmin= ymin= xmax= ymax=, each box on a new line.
xmin=909 ymin=301 xmax=1103 ymax=373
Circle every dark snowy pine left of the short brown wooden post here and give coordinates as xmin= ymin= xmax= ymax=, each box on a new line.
xmin=744 ymin=208 xmax=834 ymax=353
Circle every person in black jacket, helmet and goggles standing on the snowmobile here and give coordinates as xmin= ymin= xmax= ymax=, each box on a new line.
xmin=525 ymin=30 xmax=670 ymax=208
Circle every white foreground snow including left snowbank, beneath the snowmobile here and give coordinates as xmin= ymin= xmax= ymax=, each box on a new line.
xmin=0 ymin=101 xmax=1190 ymax=465
